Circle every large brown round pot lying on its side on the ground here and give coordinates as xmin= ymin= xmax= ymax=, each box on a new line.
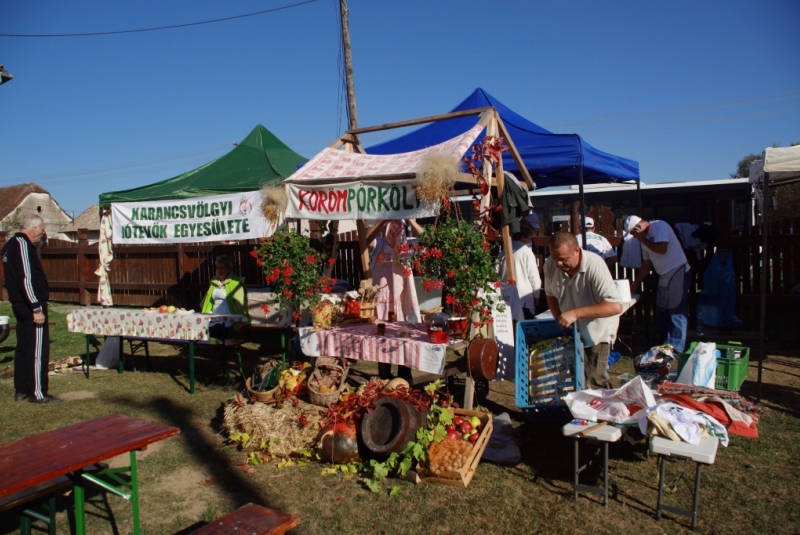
xmin=361 ymin=397 xmax=427 ymax=458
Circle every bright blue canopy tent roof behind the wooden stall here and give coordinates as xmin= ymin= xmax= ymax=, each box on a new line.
xmin=366 ymin=88 xmax=639 ymax=188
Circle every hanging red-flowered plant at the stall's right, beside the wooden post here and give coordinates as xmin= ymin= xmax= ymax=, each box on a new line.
xmin=410 ymin=207 xmax=502 ymax=328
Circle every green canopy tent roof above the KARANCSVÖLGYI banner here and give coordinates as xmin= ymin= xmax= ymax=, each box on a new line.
xmin=100 ymin=125 xmax=308 ymax=208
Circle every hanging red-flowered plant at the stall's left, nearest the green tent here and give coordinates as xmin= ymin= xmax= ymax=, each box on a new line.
xmin=250 ymin=227 xmax=335 ymax=321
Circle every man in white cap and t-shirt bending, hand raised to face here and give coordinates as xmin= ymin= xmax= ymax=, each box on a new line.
xmin=625 ymin=215 xmax=691 ymax=353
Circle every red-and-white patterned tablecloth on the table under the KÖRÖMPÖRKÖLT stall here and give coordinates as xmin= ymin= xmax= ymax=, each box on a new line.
xmin=299 ymin=322 xmax=447 ymax=375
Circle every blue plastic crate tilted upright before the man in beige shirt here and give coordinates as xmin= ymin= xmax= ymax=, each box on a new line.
xmin=515 ymin=319 xmax=585 ymax=421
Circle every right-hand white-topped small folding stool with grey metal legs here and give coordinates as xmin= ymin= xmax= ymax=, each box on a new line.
xmin=650 ymin=437 xmax=719 ymax=530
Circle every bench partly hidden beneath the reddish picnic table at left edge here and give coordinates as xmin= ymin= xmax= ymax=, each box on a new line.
xmin=0 ymin=463 xmax=108 ymax=535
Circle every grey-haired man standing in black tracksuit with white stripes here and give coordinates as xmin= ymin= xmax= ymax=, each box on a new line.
xmin=2 ymin=214 xmax=59 ymax=403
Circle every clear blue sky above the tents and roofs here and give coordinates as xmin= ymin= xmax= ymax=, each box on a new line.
xmin=0 ymin=0 xmax=800 ymax=215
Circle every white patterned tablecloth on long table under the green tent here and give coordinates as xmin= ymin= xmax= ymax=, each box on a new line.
xmin=67 ymin=308 xmax=247 ymax=342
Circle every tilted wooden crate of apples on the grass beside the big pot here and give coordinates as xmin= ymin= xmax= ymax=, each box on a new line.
xmin=417 ymin=409 xmax=492 ymax=487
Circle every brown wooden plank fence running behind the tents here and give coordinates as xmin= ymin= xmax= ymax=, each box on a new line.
xmin=0 ymin=209 xmax=800 ymax=332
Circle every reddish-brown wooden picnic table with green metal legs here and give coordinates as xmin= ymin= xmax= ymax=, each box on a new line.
xmin=0 ymin=414 xmax=180 ymax=535
